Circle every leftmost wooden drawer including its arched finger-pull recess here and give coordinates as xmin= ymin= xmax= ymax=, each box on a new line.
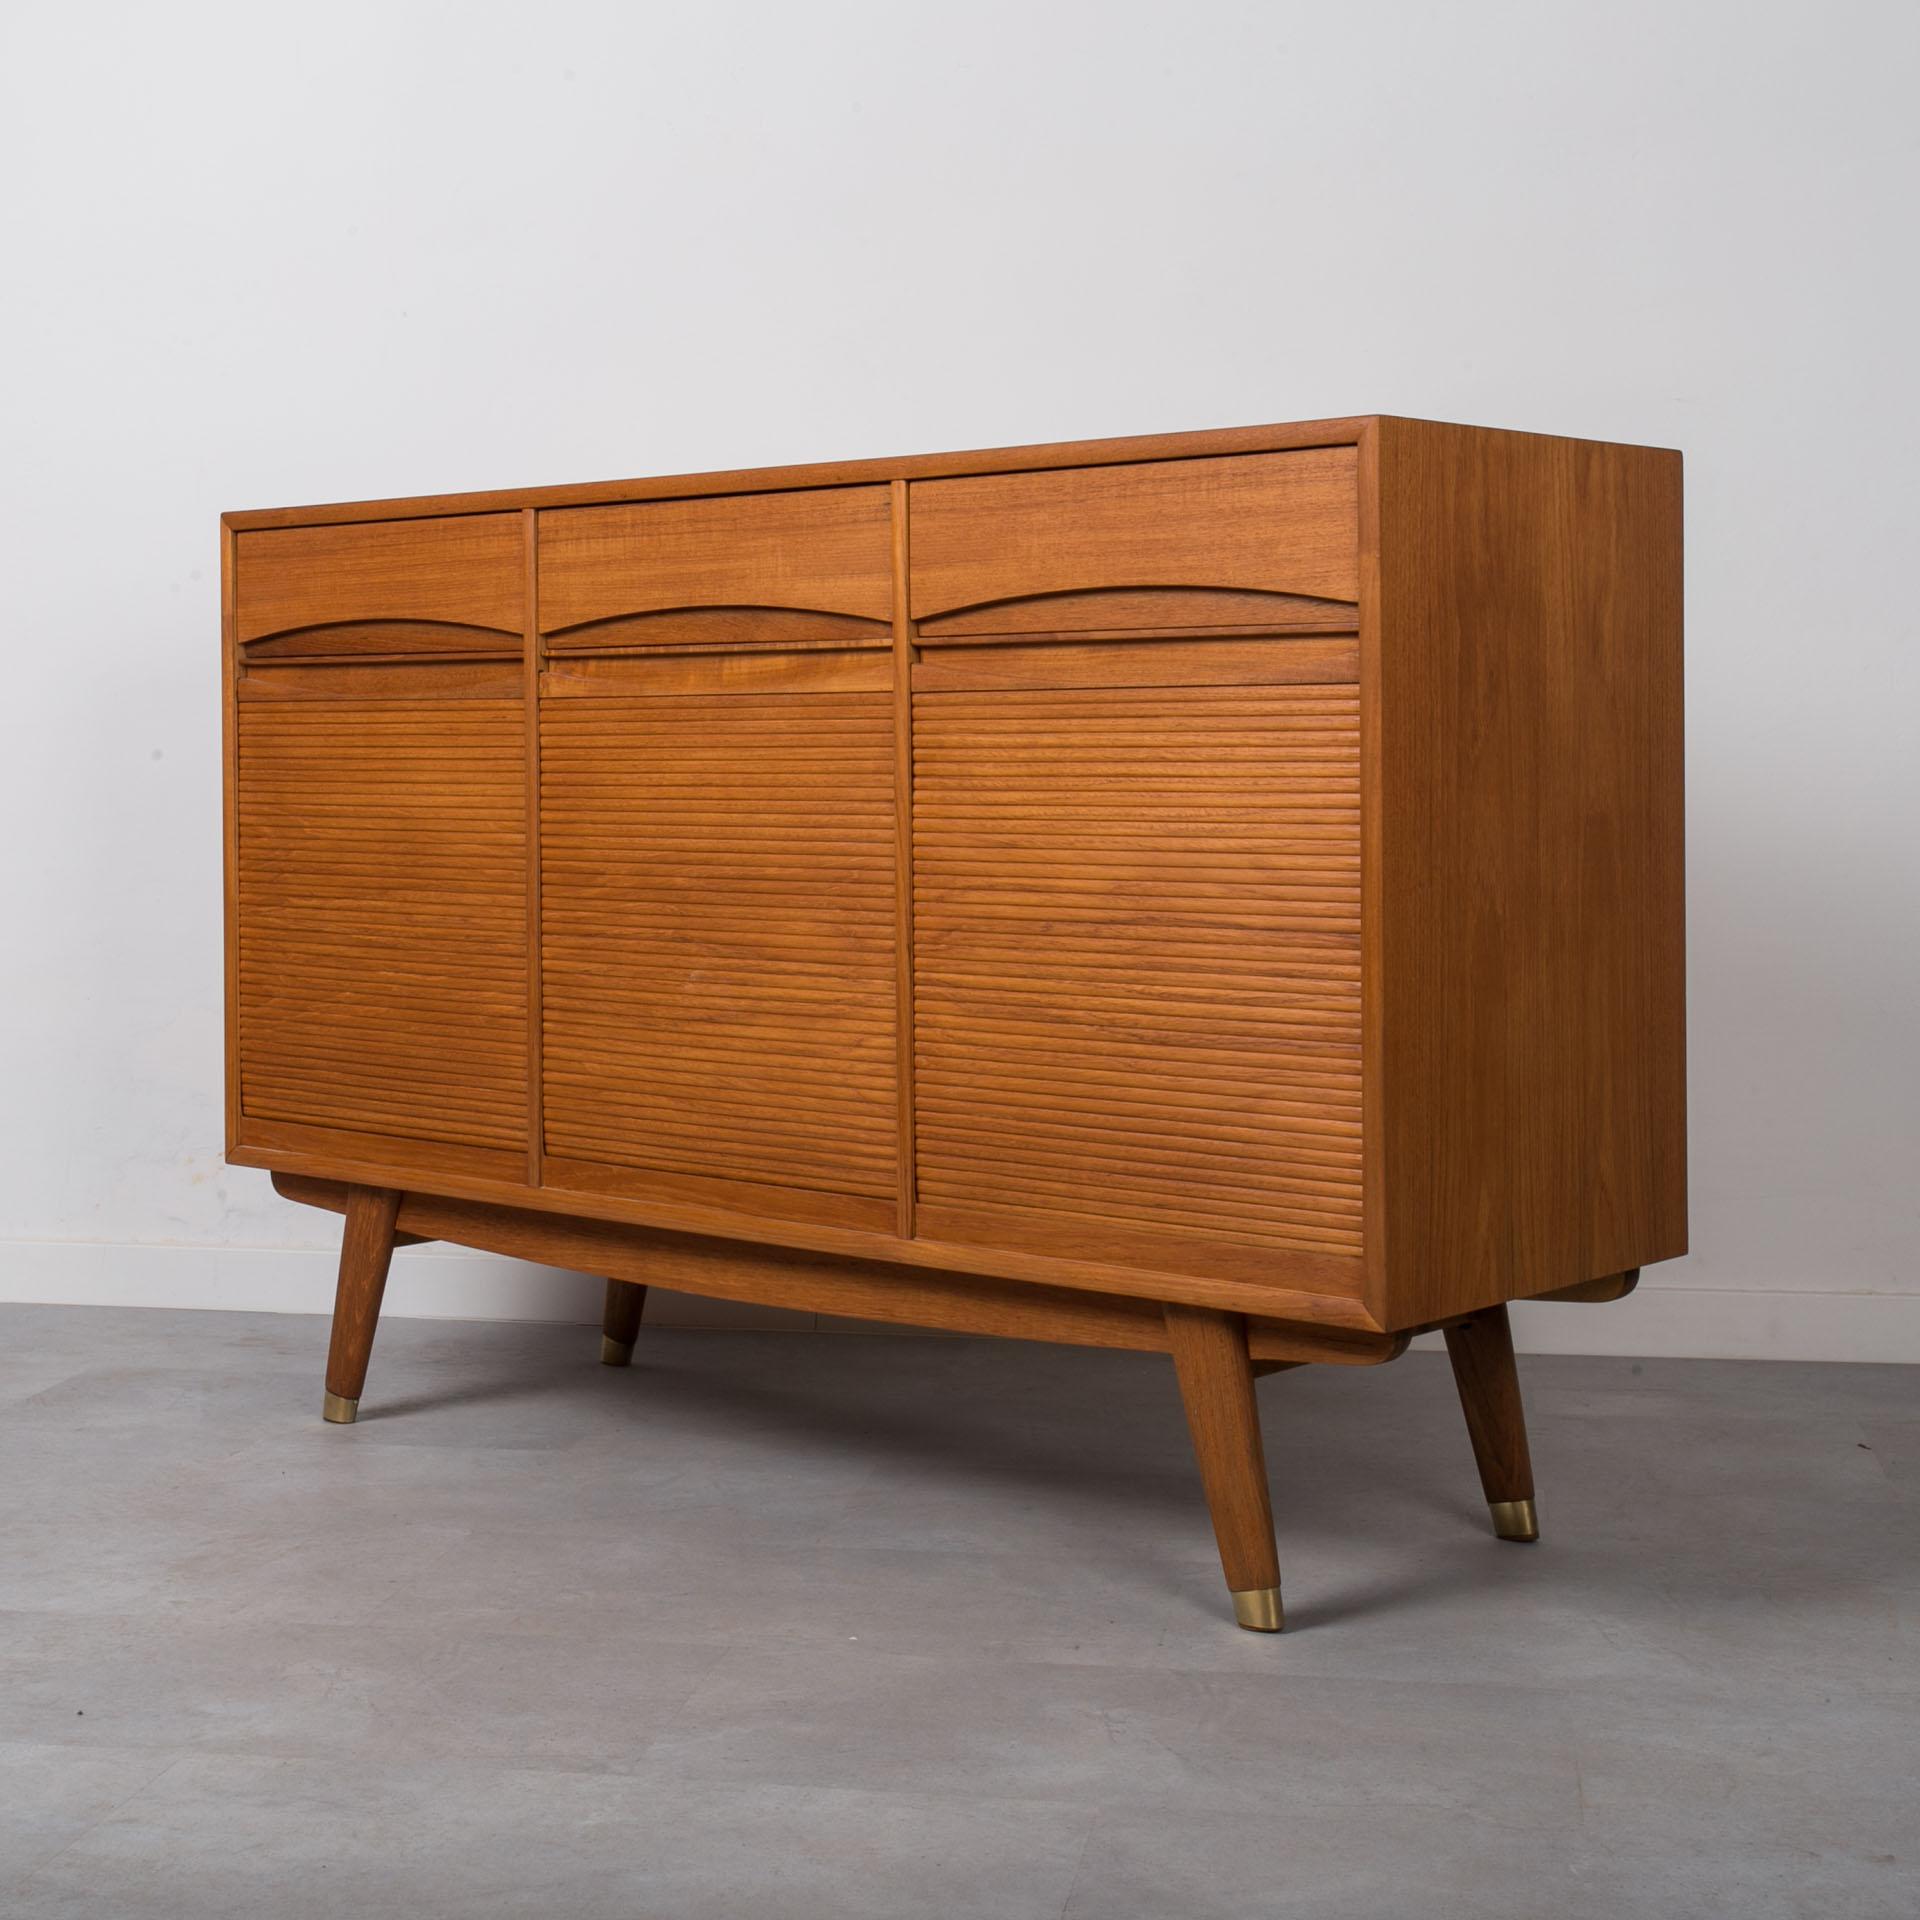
xmin=234 ymin=513 xmax=526 ymax=659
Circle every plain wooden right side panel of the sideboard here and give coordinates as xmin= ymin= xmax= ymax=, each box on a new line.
xmin=1373 ymin=420 xmax=1686 ymax=1327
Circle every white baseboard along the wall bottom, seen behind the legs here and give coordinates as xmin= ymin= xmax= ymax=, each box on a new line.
xmin=0 ymin=1240 xmax=1920 ymax=1363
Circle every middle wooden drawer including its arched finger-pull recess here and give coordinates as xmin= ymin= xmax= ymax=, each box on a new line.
xmin=540 ymin=486 xmax=893 ymax=653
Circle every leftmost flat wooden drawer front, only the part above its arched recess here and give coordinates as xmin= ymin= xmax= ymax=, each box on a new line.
xmin=234 ymin=513 xmax=526 ymax=645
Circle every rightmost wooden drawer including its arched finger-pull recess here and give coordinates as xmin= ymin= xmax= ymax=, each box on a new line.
xmin=910 ymin=447 xmax=1359 ymax=641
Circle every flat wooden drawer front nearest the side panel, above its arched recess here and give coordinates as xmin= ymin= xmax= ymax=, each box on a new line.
xmin=912 ymin=447 xmax=1359 ymax=626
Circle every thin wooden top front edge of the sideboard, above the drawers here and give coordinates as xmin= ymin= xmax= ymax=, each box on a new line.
xmin=221 ymin=415 xmax=1674 ymax=532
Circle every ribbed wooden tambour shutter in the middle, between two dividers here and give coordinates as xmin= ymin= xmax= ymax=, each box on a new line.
xmin=541 ymin=693 xmax=897 ymax=1200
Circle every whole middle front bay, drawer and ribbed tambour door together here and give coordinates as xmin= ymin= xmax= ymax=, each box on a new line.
xmin=540 ymin=488 xmax=900 ymax=1229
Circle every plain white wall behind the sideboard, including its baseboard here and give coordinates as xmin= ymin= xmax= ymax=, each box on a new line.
xmin=0 ymin=0 xmax=1920 ymax=1359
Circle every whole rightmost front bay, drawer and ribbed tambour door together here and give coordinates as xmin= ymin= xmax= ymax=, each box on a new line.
xmin=910 ymin=447 xmax=1363 ymax=1292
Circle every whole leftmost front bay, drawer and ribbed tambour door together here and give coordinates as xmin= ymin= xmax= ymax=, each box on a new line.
xmin=230 ymin=515 xmax=528 ymax=1179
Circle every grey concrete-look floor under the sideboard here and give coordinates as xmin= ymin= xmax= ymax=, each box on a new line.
xmin=0 ymin=1308 xmax=1920 ymax=1920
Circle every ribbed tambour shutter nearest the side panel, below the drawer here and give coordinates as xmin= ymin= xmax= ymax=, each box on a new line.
xmin=914 ymin=685 xmax=1361 ymax=1277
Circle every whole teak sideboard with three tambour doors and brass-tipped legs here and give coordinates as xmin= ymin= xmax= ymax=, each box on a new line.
xmin=223 ymin=417 xmax=1686 ymax=1628
